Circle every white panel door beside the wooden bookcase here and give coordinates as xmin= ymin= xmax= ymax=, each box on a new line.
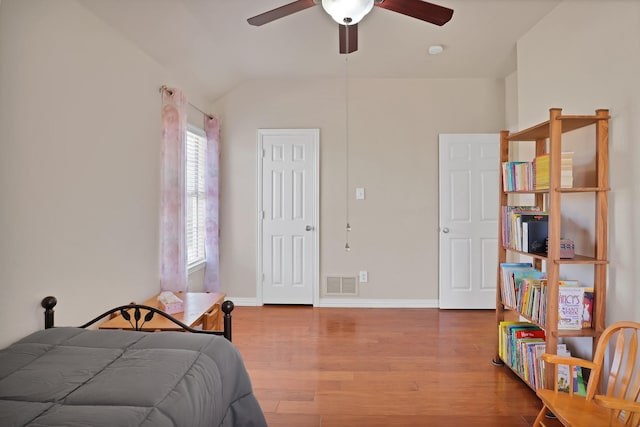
xmin=439 ymin=134 xmax=500 ymax=309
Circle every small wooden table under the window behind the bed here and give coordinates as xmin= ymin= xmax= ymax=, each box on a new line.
xmin=99 ymin=292 xmax=226 ymax=331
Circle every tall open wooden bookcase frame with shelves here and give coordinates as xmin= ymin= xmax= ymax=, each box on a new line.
xmin=494 ymin=108 xmax=610 ymax=388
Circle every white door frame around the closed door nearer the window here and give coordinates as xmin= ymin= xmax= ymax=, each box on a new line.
xmin=256 ymin=128 xmax=320 ymax=307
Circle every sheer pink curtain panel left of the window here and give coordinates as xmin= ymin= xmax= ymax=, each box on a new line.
xmin=160 ymin=87 xmax=187 ymax=291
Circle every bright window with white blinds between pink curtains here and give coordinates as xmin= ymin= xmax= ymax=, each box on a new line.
xmin=185 ymin=126 xmax=207 ymax=269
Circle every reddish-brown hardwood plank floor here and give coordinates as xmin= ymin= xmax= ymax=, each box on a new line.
xmin=233 ymin=306 xmax=540 ymax=427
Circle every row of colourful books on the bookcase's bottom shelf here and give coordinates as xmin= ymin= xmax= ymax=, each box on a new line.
xmin=498 ymin=321 xmax=587 ymax=396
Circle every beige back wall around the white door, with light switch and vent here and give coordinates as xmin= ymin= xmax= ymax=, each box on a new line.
xmin=215 ymin=79 xmax=505 ymax=305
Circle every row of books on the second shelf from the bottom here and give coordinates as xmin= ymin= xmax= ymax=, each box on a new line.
xmin=500 ymin=263 xmax=594 ymax=330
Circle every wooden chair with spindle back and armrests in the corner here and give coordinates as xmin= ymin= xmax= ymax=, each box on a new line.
xmin=533 ymin=322 xmax=640 ymax=427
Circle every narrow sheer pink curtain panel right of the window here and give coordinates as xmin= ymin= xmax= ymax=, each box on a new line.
xmin=204 ymin=116 xmax=220 ymax=292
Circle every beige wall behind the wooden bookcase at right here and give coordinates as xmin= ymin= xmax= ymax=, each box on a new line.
xmin=518 ymin=0 xmax=640 ymax=324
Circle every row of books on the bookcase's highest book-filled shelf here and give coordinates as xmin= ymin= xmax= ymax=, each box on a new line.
xmin=502 ymin=151 xmax=573 ymax=191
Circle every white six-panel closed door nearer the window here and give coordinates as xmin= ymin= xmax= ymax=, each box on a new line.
xmin=258 ymin=129 xmax=319 ymax=304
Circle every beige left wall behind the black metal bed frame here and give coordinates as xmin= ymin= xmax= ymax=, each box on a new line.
xmin=0 ymin=0 xmax=205 ymax=346
